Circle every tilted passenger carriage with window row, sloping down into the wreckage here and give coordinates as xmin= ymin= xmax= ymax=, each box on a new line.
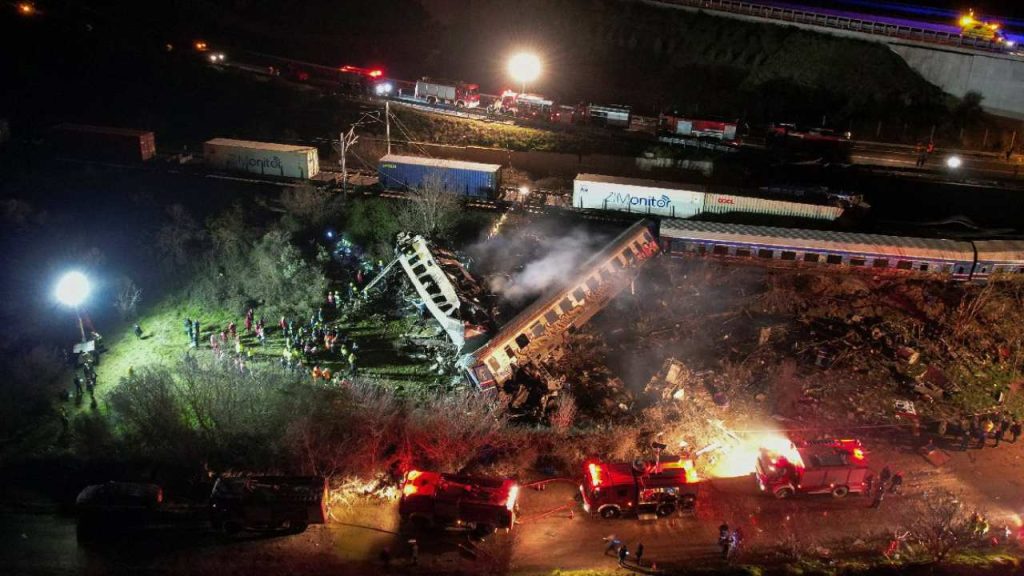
xmin=463 ymin=219 xmax=658 ymax=390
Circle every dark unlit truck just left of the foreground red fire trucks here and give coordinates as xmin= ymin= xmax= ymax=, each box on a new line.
xmin=210 ymin=477 xmax=328 ymax=534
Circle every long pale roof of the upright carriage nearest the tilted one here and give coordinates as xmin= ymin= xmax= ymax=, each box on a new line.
xmin=662 ymin=218 xmax=970 ymax=262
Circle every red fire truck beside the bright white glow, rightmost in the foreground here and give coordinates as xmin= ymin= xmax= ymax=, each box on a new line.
xmin=755 ymin=440 xmax=872 ymax=499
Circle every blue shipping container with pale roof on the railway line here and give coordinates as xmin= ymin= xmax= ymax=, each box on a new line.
xmin=378 ymin=154 xmax=502 ymax=198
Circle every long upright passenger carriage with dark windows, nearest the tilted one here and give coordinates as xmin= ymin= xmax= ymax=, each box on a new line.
xmin=660 ymin=218 xmax=975 ymax=280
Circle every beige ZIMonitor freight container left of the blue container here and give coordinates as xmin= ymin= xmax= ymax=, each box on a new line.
xmin=203 ymin=138 xmax=319 ymax=179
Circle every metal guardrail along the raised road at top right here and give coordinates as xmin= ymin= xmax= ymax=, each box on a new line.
xmin=658 ymin=0 xmax=1004 ymax=52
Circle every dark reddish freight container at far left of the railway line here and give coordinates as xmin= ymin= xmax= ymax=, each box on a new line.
xmin=51 ymin=124 xmax=157 ymax=162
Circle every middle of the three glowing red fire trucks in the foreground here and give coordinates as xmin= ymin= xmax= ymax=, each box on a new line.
xmin=580 ymin=456 xmax=700 ymax=519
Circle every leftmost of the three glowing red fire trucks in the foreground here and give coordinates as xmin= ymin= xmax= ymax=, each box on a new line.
xmin=398 ymin=470 xmax=519 ymax=536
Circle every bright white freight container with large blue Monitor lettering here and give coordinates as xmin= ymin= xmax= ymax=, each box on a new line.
xmin=572 ymin=174 xmax=705 ymax=218
